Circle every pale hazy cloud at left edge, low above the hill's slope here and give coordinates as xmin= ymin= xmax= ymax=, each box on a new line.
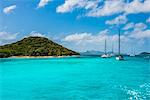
xmin=0 ymin=31 xmax=18 ymax=45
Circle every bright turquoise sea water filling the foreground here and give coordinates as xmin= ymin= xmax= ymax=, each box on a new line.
xmin=0 ymin=57 xmax=150 ymax=100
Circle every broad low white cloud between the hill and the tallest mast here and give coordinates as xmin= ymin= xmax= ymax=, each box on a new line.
xmin=63 ymin=30 xmax=117 ymax=51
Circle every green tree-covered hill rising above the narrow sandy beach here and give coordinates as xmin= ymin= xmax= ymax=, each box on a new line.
xmin=0 ymin=37 xmax=79 ymax=58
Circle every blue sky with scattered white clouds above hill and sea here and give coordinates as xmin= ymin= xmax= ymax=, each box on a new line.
xmin=0 ymin=0 xmax=150 ymax=54
